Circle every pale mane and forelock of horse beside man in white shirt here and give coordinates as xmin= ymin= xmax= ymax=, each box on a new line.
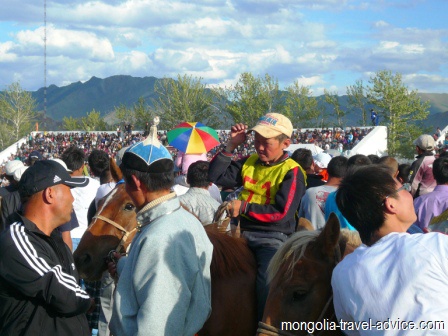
xmin=268 ymin=229 xmax=361 ymax=282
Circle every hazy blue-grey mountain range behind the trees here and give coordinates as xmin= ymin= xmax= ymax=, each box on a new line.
xmin=31 ymin=75 xmax=448 ymax=130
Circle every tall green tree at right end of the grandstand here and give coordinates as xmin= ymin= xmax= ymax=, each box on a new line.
xmin=367 ymin=70 xmax=430 ymax=158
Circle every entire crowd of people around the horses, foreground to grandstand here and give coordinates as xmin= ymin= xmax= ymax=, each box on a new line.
xmin=0 ymin=113 xmax=448 ymax=336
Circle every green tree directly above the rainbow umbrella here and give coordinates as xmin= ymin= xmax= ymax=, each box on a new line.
xmin=151 ymin=75 xmax=219 ymax=129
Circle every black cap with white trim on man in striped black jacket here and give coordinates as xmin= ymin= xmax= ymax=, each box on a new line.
xmin=19 ymin=160 xmax=89 ymax=197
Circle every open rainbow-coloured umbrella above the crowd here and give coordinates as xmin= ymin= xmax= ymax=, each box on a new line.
xmin=167 ymin=122 xmax=220 ymax=154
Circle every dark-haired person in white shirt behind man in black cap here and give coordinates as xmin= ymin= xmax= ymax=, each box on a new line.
xmin=61 ymin=146 xmax=100 ymax=251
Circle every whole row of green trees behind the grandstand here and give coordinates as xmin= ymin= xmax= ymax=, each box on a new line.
xmin=0 ymin=70 xmax=430 ymax=157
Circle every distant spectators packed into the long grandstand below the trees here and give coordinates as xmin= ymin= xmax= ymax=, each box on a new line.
xmin=1 ymin=125 xmax=373 ymax=172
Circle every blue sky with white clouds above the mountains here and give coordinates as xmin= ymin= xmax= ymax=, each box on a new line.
xmin=0 ymin=0 xmax=448 ymax=95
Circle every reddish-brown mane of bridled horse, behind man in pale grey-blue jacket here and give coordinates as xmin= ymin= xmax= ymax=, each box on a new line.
xmin=206 ymin=227 xmax=257 ymax=278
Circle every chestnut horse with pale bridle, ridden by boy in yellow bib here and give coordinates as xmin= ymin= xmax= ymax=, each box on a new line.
xmin=74 ymin=160 xmax=257 ymax=336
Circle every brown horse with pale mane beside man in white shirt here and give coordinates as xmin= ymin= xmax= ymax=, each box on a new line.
xmin=257 ymin=213 xmax=361 ymax=336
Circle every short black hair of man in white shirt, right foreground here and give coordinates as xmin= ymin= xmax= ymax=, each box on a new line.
xmin=336 ymin=165 xmax=397 ymax=245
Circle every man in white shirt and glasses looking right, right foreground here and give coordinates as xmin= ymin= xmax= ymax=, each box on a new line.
xmin=331 ymin=165 xmax=448 ymax=335
